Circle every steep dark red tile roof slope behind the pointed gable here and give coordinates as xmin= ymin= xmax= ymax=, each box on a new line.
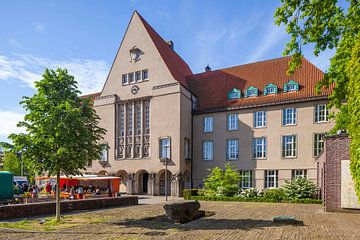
xmin=136 ymin=12 xmax=193 ymax=88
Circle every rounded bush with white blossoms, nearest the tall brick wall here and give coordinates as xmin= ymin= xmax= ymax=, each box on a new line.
xmin=283 ymin=177 xmax=316 ymax=199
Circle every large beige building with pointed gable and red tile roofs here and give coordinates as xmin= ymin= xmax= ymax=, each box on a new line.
xmin=86 ymin=12 xmax=333 ymax=196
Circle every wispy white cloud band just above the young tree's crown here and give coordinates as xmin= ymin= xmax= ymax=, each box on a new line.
xmin=0 ymin=54 xmax=108 ymax=94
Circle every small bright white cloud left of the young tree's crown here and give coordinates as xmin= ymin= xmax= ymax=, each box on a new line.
xmin=0 ymin=109 xmax=24 ymax=138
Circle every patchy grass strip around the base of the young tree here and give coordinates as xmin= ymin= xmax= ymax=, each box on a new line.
xmin=0 ymin=214 xmax=107 ymax=232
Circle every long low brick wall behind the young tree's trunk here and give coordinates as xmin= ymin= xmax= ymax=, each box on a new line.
xmin=0 ymin=196 xmax=138 ymax=220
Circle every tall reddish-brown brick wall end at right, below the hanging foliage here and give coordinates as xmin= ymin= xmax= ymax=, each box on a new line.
xmin=317 ymin=134 xmax=350 ymax=211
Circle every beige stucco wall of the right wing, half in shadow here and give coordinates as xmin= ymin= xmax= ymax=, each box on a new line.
xmin=193 ymin=101 xmax=334 ymax=188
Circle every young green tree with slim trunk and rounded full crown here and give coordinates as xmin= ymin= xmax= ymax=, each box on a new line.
xmin=9 ymin=69 xmax=105 ymax=221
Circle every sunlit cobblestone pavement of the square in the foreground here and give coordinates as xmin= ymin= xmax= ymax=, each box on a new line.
xmin=0 ymin=202 xmax=360 ymax=240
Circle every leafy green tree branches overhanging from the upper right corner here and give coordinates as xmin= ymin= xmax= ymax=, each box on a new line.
xmin=275 ymin=0 xmax=360 ymax=196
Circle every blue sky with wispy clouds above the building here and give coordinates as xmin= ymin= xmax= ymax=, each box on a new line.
xmin=0 ymin=0 xmax=333 ymax=141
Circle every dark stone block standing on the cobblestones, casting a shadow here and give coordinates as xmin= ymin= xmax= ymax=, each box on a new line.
xmin=164 ymin=200 xmax=205 ymax=223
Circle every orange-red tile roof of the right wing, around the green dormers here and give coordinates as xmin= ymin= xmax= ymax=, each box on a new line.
xmin=187 ymin=57 xmax=331 ymax=112
